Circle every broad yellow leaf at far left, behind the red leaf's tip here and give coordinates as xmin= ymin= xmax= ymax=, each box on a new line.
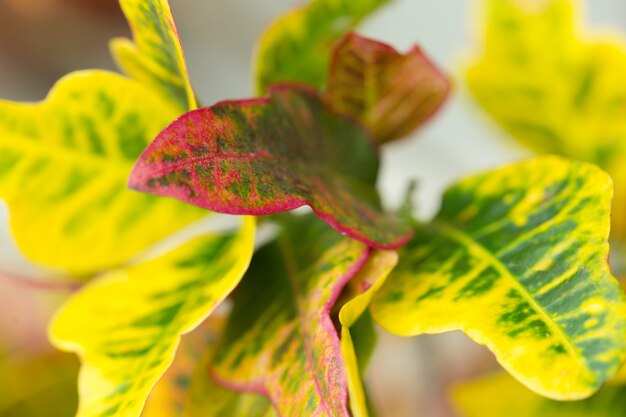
xmin=0 ymin=71 xmax=206 ymax=275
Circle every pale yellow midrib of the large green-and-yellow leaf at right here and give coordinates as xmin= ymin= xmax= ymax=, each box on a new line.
xmin=431 ymin=219 xmax=589 ymax=369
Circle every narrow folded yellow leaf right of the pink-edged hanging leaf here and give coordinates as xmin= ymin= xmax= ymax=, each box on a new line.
xmin=339 ymin=251 xmax=398 ymax=417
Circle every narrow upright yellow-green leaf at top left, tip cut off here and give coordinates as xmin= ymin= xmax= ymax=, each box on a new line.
xmin=110 ymin=0 xmax=198 ymax=111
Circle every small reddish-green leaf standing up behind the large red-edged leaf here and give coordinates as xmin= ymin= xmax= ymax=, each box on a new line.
xmin=326 ymin=33 xmax=451 ymax=143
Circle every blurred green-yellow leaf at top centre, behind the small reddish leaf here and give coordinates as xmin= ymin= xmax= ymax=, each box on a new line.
xmin=255 ymin=0 xmax=391 ymax=94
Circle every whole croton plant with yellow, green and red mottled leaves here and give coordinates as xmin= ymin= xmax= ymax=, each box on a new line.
xmin=0 ymin=0 xmax=626 ymax=417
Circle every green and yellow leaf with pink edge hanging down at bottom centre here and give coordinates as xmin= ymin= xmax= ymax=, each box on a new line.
xmin=212 ymin=216 xmax=369 ymax=417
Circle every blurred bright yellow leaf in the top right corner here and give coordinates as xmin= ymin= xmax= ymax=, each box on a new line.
xmin=466 ymin=0 xmax=626 ymax=238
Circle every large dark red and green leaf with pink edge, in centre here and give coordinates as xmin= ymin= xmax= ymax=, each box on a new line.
xmin=129 ymin=85 xmax=411 ymax=249
